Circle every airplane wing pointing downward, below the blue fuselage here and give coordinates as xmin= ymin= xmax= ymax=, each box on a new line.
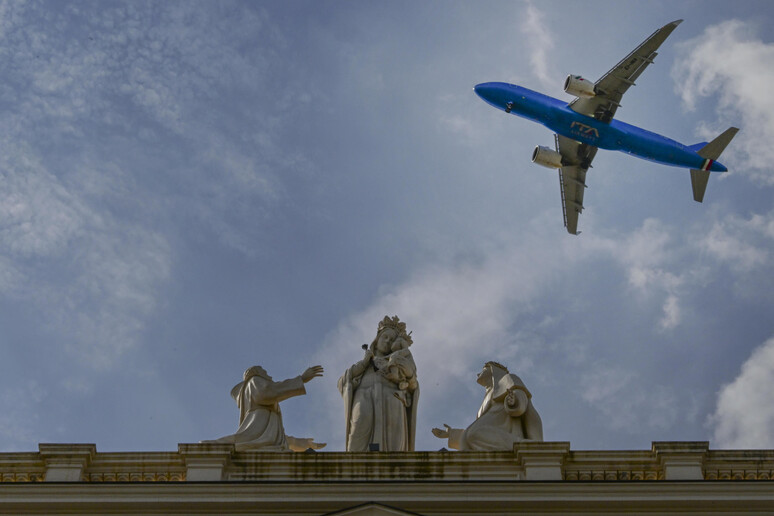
xmin=555 ymin=134 xmax=597 ymax=235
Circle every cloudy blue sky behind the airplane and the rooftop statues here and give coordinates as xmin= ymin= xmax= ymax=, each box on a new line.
xmin=0 ymin=0 xmax=774 ymax=451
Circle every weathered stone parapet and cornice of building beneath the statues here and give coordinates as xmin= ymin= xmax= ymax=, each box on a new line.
xmin=0 ymin=442 xmax=774 ymax=515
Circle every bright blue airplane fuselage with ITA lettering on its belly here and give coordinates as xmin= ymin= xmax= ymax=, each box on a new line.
xmin=474 ymin=82 xmax=728 ymax=172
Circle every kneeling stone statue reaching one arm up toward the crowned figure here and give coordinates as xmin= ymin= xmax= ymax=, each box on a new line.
xmin=202 ymin=366 xmax=325 ymax=451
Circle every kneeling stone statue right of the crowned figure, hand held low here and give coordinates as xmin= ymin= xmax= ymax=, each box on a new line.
xmin=433 ymin=362 xmax=543 ymax=451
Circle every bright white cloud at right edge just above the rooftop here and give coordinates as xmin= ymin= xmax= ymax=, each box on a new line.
xmin=710 ymin=338 xmax=774 ymax=449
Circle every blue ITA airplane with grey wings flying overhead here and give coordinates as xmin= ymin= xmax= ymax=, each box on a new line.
xmin=473 ymin=20 xmax=739 ymax=235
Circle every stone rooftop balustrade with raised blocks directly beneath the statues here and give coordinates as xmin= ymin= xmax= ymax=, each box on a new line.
xmin=0 ymin=441 xmax=774 ymax=482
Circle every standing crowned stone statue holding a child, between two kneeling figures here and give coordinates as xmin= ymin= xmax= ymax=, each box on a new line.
xmin=339 ymin=316 xmax=419 ymax=451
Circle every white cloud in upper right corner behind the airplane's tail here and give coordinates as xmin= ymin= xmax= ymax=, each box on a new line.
xmin=672 ymin=20 xmax=774 ymax=185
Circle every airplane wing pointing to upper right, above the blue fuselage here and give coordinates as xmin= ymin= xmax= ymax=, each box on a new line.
xmin=570 ymin=20 xmax=683 ymax=123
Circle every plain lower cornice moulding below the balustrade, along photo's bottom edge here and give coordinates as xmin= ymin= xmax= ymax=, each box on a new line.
xmin=0 ymin=480 xmax=774 ymax=515
